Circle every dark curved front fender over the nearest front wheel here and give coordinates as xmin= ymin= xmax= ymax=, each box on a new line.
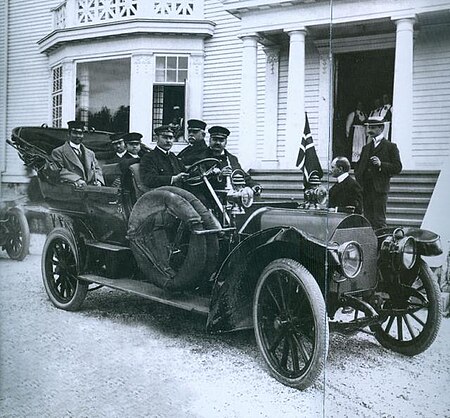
xmin=207 ymin=226 xmax=337 ymax=332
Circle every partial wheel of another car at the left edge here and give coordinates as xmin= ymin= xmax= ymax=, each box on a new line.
xmin=5 ymin=208 xmax=30 ymax=261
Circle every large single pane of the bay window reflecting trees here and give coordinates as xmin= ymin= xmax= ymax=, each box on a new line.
xmin=75 ymin=58 xmax=131 ymax=132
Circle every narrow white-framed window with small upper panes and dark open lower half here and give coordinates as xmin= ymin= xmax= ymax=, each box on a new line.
xmin=153 ymin=55 xmax=189 ymax=140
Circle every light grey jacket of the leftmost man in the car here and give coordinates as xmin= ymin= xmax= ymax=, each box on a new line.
xmin=52 ymin=142 xmax=105 ymax=184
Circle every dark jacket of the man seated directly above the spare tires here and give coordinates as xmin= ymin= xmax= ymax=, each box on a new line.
xmin=140 ymin=148 xmax=186 ymax=188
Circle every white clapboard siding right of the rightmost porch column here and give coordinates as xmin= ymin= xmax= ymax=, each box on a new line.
xmin=414 ymin=26 xmax=450 ymax=169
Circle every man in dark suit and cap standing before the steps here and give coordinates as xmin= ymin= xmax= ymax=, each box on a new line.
xmin=355 ymin=117 xmax=402 ymax=229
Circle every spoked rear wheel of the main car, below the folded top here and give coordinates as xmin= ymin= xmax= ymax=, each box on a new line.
xmin=42 ymin=228 xmax=89 ymax=311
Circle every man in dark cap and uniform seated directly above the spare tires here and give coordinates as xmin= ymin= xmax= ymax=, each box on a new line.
xmin=140 ymin=125 xmax=188 ymax=188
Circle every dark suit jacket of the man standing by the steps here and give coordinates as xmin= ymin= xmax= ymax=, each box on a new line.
xmin=355 ymin=138 xmax=402 ymax=193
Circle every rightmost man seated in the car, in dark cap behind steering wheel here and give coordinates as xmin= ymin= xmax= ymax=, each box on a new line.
xmin=198 ymin=126 xmax=262 ymax=195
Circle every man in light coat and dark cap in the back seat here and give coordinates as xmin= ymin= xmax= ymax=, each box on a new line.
xmin=52 ymin=121 xmax=105 ymax=187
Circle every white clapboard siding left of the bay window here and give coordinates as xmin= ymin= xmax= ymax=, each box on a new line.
xmin=4 ymin=0 xmax=60 ymax=181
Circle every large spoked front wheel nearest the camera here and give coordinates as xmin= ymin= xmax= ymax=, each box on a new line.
xmin=253 ymin=259 xmax=329 ymax=389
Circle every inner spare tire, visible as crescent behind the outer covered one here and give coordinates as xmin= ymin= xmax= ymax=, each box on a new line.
xmin=159 ymin=186 xmax=222 ymax=277
